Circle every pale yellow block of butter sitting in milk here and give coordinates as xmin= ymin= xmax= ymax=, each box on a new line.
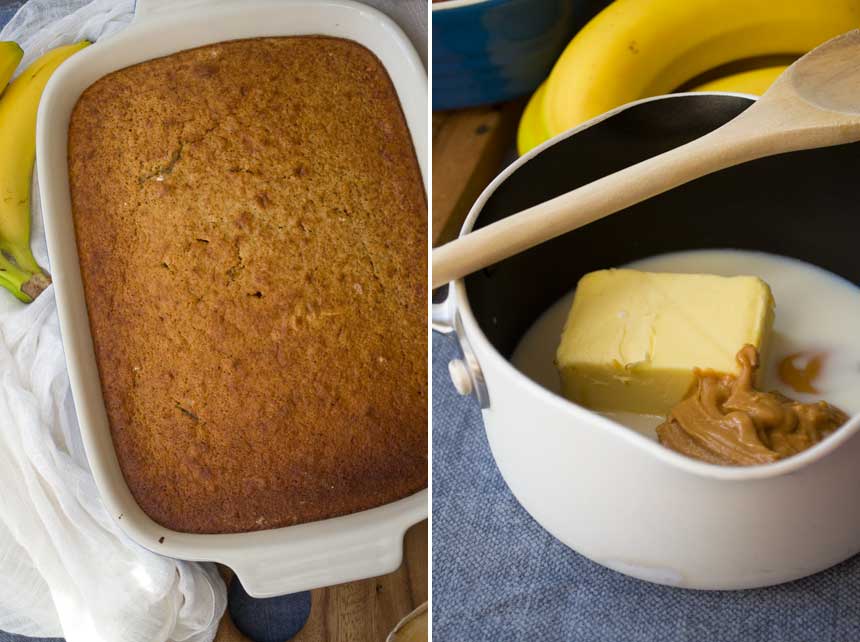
xmin=556 ymin=270 xmax=774 ymax=415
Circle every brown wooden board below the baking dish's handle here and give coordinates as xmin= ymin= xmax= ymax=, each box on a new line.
xmin=215 ymin=520 xmax=427 ymax=642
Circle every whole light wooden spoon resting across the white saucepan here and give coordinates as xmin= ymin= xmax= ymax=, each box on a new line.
xmin=433 ymin=30 xmax=860 ymax=288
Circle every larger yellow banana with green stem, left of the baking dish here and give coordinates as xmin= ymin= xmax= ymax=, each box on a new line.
xmin=0 ymin=41 xmax=89 ymax=303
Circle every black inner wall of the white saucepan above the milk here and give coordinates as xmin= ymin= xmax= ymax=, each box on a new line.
xmin=466 ymin=94 xmax=860 ymax=357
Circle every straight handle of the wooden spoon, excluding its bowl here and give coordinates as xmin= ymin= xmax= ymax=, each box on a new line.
xmin=432 ymin=108 xmax=772 ymax=289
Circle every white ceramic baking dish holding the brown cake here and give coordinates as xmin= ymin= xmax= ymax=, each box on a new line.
xmin=36 ymin=0 xmax=427 ymax=597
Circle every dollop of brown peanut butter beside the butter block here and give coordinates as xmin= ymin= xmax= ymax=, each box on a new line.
xmin=657 ymin=345 xmax=848 ymax=466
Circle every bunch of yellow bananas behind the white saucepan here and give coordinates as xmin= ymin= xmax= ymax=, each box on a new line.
xmin=517 ymin=0 xmax=860 ymax=154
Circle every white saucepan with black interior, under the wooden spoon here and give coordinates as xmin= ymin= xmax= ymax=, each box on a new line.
xmin=433 ymin=93 xmax=860 ymax=589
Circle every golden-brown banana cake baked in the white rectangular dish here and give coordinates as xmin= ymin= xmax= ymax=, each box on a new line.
xmin=68 ymin=36 xmax=427 ymax=533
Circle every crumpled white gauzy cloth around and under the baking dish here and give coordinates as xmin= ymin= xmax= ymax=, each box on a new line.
xmin=0 ymin=0 xmax=427 ymax=642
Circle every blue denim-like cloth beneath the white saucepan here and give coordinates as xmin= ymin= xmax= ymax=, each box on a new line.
xmin=433 ymin=334 xmax=860 ymax=642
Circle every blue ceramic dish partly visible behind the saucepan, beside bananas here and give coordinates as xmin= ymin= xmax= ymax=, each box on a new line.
xmin=432 ymin=0 xmax=606 ymax=109
